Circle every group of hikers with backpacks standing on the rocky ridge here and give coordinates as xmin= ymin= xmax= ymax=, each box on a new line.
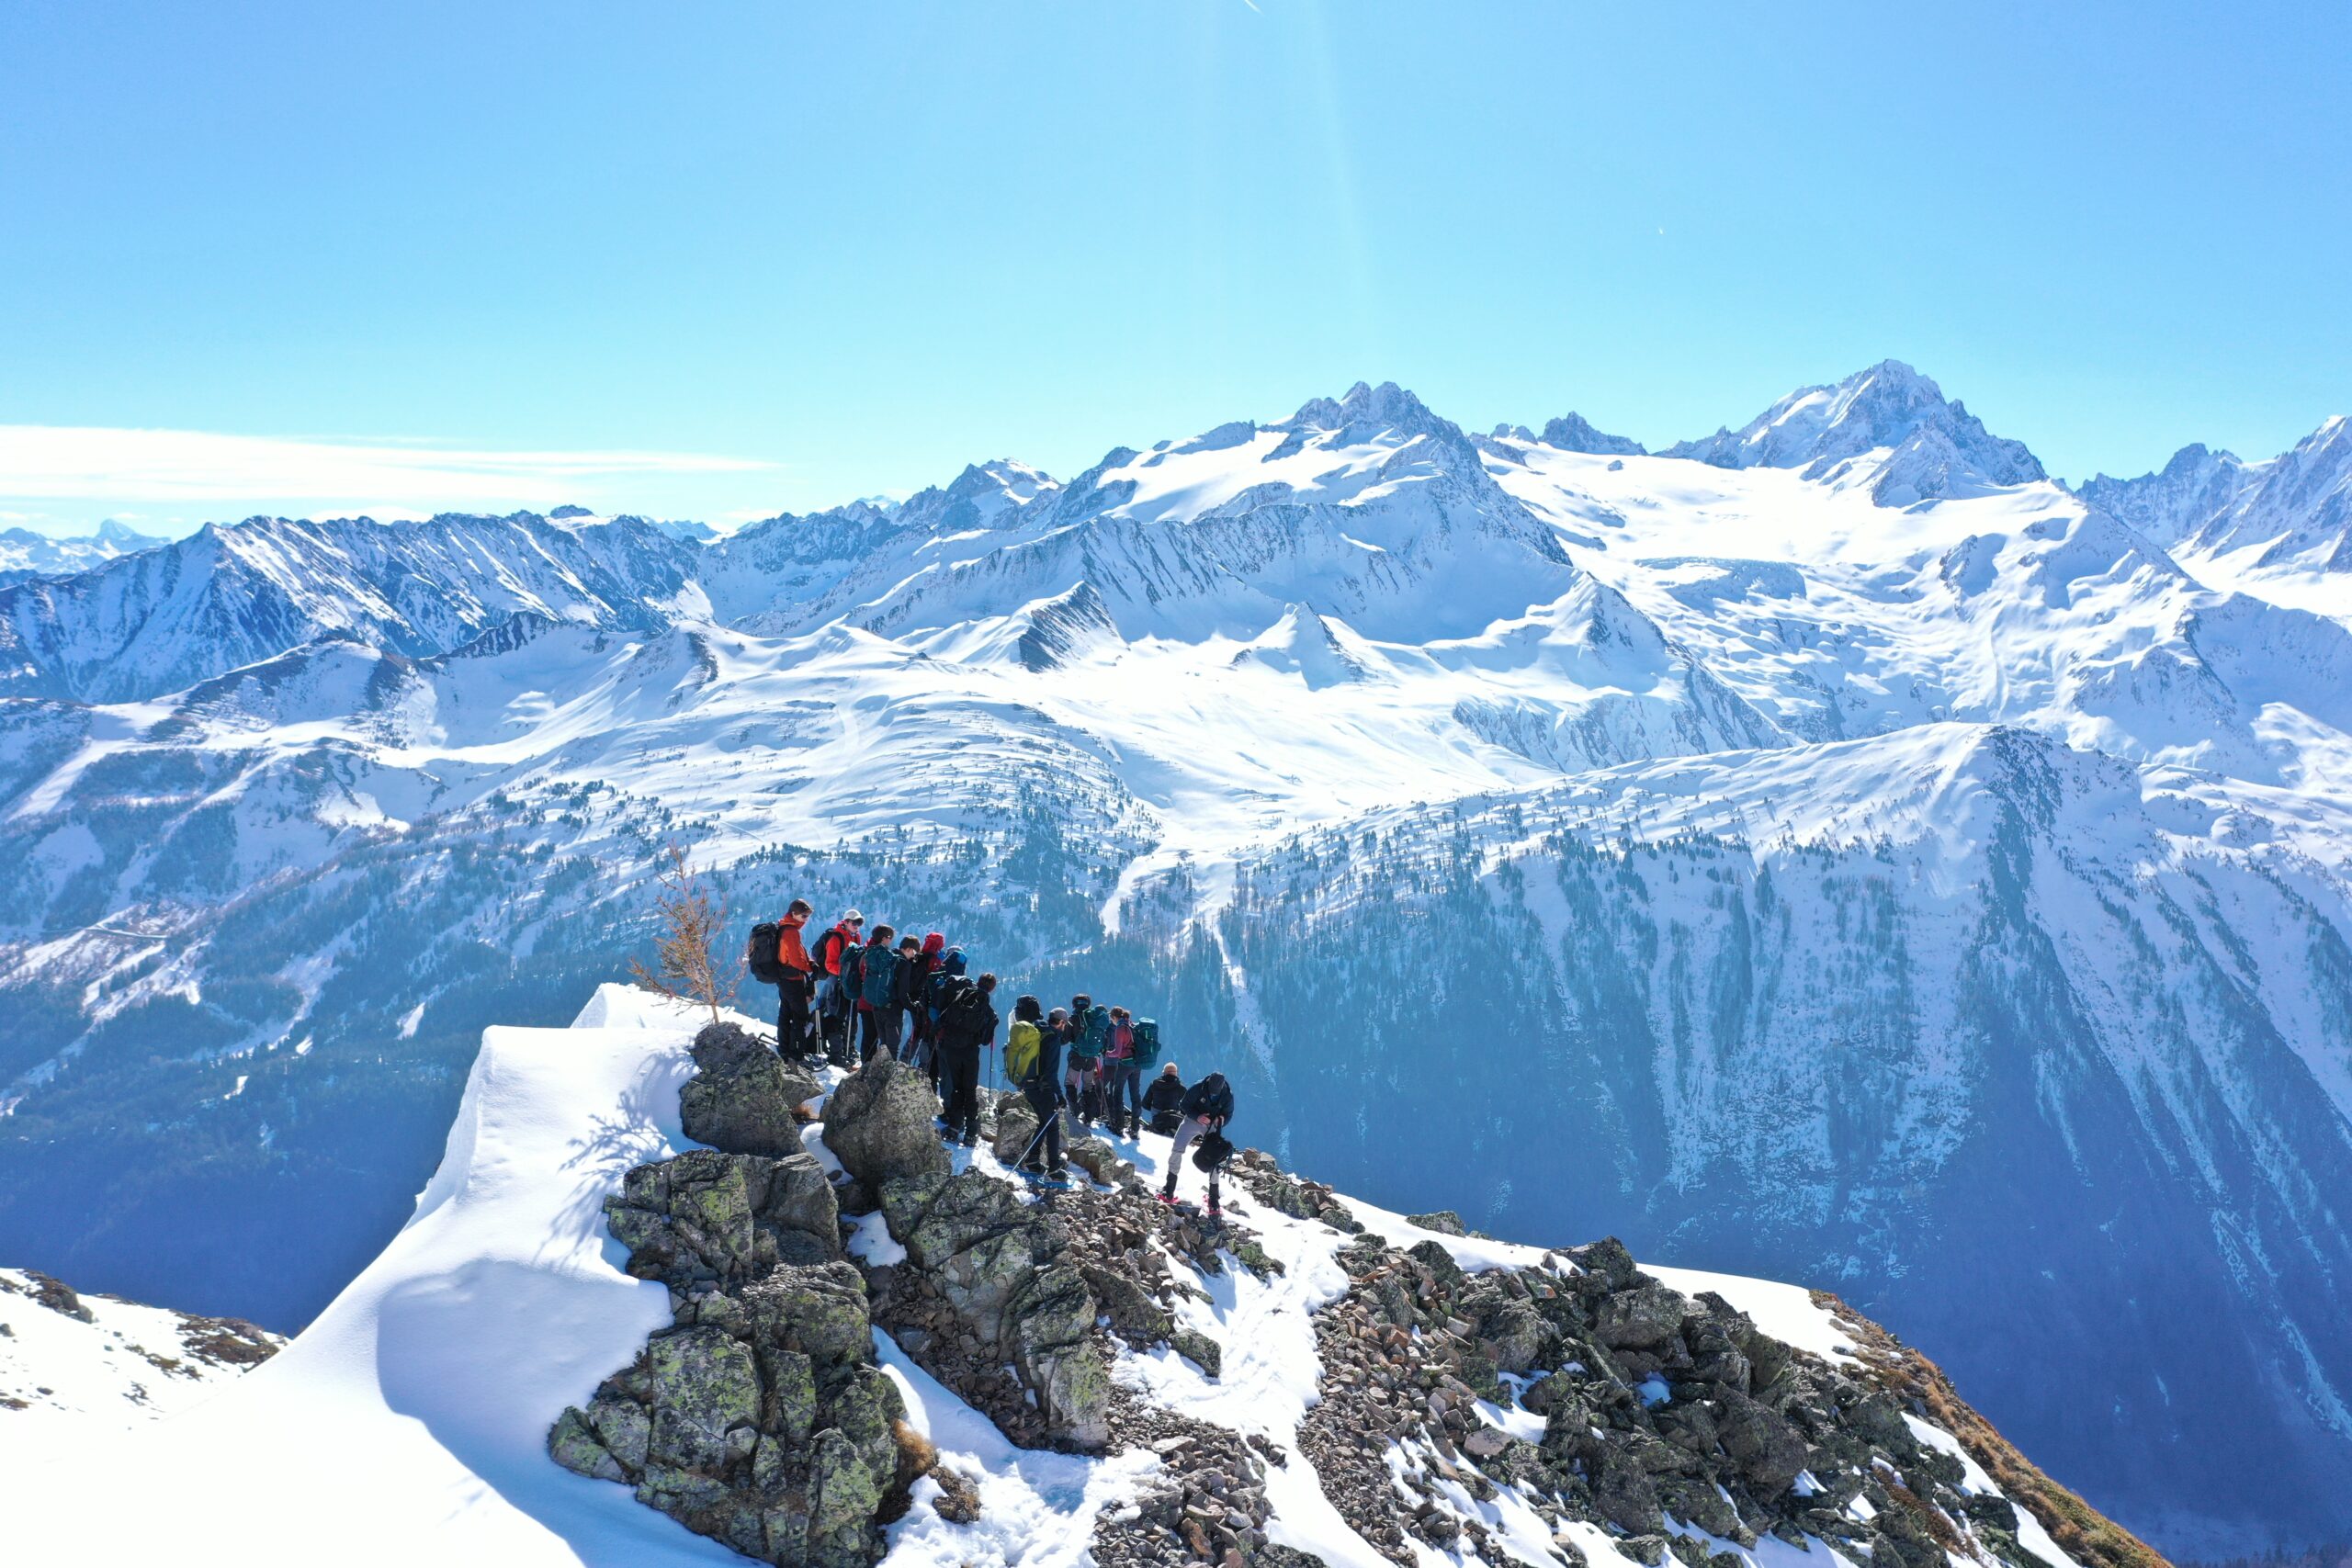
xmin=746 ymin=898 xmax=1232 ymax=1215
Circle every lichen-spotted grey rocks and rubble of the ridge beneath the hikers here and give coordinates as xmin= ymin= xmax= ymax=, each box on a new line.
xmin=548 ymin=1022 xmax=2162 ymax=1568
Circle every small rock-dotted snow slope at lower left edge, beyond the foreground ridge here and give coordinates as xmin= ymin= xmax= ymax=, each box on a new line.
xmin=0 ymin=1269 xmax=285 ymax=1483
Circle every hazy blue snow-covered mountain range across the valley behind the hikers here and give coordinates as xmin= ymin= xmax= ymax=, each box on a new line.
xmin=0 ymin=365 xmax=2352 ymax=1550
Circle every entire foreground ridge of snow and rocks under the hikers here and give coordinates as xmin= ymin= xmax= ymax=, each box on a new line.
xmin=9 ymin=985 xmax=2157 ymax=1568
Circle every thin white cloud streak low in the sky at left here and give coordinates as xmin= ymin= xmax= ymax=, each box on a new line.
xmin=0 ymin=425 xmax=776 ymax=513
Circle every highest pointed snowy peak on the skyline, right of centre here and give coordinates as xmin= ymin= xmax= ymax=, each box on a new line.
xmin=1663 ymin=360 xmax=2049 ymax=503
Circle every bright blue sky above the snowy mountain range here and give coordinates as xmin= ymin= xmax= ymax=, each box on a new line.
xmin=0 ymin=0 xmax=2352 ymax=529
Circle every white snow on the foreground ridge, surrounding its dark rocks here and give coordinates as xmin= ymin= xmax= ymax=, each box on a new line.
xmin=7 ymin=985 xmax=2135 ymax=1568
